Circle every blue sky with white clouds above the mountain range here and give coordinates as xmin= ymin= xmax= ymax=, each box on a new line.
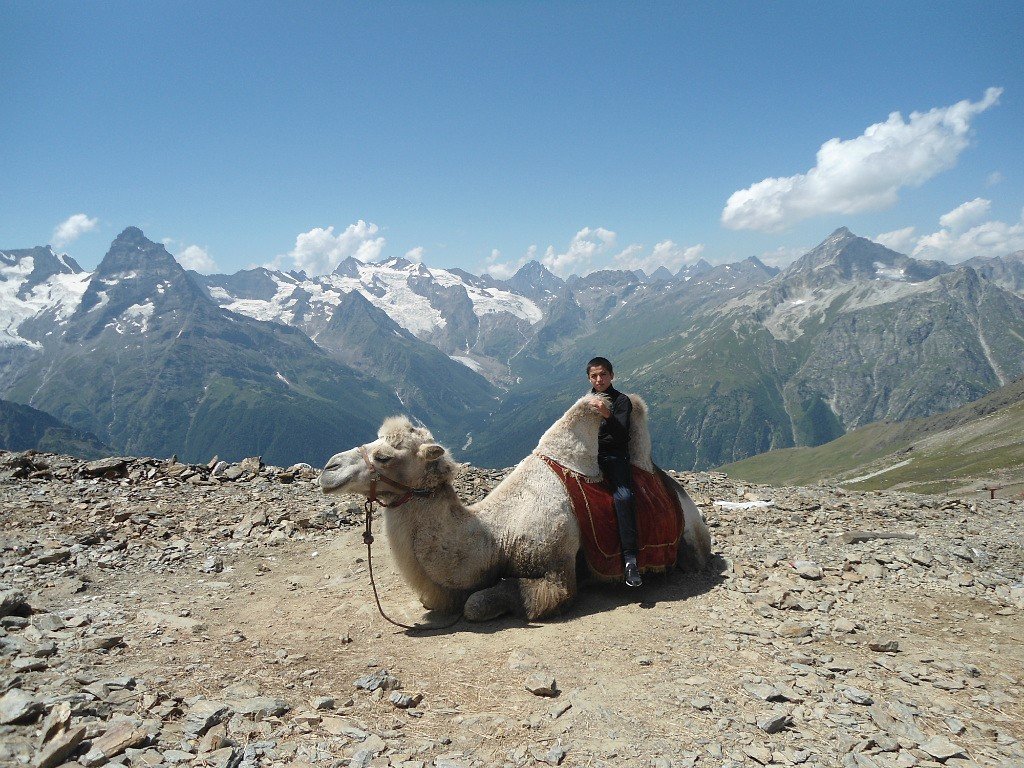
xmin=0 ymin=2 xmax=1024 ymax=275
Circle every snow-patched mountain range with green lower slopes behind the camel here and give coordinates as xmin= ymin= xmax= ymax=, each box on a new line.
xmin=0 ymin=227 xmax=1024 ymax=468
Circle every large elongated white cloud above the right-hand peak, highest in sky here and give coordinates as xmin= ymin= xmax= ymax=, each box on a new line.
xmin=722 ymin=88 xmax=1002 ymax=231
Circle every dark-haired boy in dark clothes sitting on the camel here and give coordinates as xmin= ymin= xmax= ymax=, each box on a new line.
xmin=587 ymin=357 xmax=643 ymax=587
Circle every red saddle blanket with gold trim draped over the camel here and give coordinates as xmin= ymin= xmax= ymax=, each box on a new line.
xmin=539 ymin=456 xmax=683 ymax=578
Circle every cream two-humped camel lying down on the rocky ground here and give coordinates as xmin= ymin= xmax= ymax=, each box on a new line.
xmin=321 ymin=394 xmax=711 ymax=622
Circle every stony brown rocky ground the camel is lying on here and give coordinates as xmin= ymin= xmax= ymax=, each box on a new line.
xmin=0 ymin=454 xmax=1024 ymax=768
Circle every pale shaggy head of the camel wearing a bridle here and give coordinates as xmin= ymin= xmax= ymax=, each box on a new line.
xmin=321 ymin=416 xmax=457 ymax=504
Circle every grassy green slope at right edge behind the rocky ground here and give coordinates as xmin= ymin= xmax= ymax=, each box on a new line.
xmin=720 ymin=379 xmax=1024 ymax=493
